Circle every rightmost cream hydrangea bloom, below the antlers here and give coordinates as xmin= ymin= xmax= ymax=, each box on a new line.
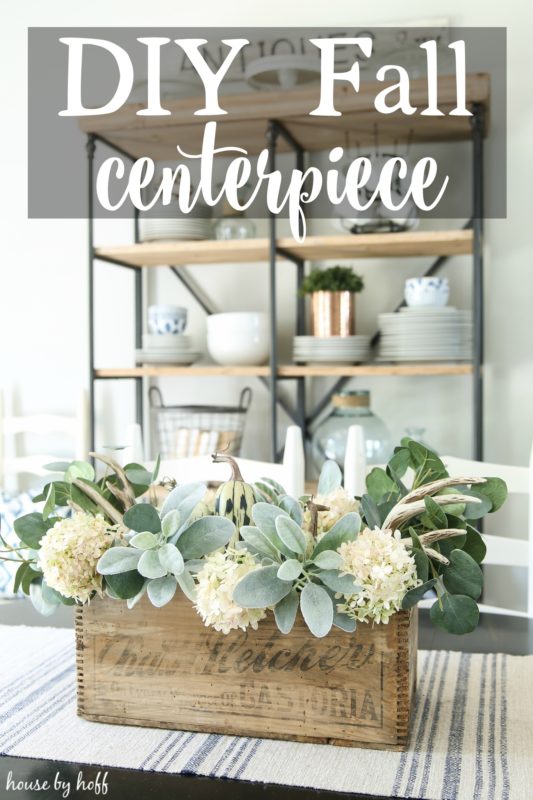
xmin=338 ymin=528 xmax=422 ymax=623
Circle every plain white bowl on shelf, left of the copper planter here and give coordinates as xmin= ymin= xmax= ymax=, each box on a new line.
xmin=207 ymin=311 xmax=270 ymax=366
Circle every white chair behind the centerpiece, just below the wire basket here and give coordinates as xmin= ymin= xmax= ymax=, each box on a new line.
xmin=151 ymin=425 xmax=305 ymax=497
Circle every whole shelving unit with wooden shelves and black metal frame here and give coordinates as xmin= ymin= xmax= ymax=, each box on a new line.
xmin=81 ymin=75 xmax=490 ymax=459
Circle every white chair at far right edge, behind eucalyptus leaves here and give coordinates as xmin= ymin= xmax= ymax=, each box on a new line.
xmin=442 ymin=447 xmax=533 ymax=617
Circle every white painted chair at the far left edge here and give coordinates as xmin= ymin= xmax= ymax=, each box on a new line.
xmin=0 ymin=389 xmax=89 ymax=493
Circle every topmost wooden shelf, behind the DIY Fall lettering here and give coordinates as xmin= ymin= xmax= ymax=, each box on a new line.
xmin=79 ymin=74 xmax=490 ymax=161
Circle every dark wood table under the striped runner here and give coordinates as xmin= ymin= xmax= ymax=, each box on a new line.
xmin=0 ymin=611 xmax=533 ymax=800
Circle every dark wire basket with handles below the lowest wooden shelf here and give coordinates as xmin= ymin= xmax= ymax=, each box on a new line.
xmin=149 ymin=386 xmax=252 ymax=459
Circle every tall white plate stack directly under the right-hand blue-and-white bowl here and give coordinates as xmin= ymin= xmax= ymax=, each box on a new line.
xmin=378 ymin=306 xmax=472 ymax=361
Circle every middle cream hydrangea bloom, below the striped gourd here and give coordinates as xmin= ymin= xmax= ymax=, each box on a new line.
xmin=195 ymin=551 xmax=266 ymax=633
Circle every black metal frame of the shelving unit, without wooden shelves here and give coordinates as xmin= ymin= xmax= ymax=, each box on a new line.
xmin=86 ymin=104 xmax=484 ymax=461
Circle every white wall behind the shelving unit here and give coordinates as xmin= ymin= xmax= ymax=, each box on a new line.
xmin=0 ymin=0 xmax=533 ymax=608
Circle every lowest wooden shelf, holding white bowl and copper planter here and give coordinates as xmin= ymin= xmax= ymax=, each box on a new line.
xmin=95 ymin=363 xmax=473 ymax=378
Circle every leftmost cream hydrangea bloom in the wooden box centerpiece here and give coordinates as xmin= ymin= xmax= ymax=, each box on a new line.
xmin=39 ymin=511 xmax=117 ymax=603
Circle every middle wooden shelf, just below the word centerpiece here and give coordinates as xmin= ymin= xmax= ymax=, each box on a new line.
xmin=95 ymin=230 xmax=473 ymax=267
